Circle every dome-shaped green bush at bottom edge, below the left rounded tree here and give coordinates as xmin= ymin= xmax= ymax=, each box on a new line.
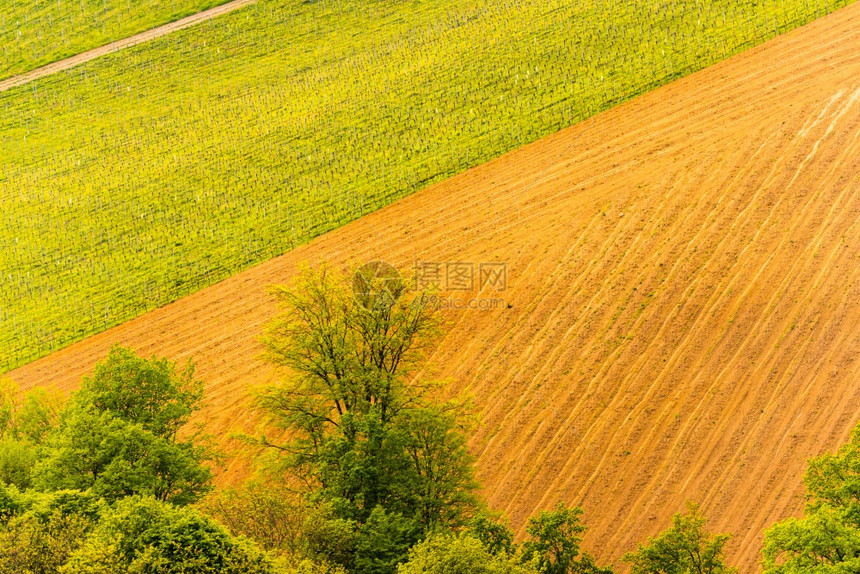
xmin=59 ymin=496 xmax=276 ymax=574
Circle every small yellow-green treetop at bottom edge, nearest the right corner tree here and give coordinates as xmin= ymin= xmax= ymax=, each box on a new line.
xmin=622 ymin=502 xmax=736 ymax=574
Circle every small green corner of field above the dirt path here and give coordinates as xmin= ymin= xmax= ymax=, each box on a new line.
xmin=0 ymin=0 xmax=232 ymax=80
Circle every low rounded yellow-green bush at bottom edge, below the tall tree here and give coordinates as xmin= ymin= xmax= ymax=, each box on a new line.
xmin=397 ymin=534 xmax=539 ymax=574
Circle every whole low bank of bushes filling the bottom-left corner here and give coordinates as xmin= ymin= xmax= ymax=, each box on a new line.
xmin=0 ymin=487 xmax=282 ymax=574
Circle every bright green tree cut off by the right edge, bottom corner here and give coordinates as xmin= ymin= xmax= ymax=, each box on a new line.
xmin=762 ymin=425 xmax=860 ymax=574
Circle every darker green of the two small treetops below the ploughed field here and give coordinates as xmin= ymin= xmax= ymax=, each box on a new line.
xmin=523 ymin=502 xmax=612 ymax=574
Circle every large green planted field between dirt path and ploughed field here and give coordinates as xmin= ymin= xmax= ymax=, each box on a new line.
xmin=0 ymin=0 xmax=850 ymax=372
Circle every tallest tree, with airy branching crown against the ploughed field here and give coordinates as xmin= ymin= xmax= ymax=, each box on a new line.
xmin=259 ymin=266 xmax=484 ymax=531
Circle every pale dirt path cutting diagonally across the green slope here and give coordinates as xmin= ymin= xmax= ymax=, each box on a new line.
xmin=0 ymin=0 xmax=255 ymax=92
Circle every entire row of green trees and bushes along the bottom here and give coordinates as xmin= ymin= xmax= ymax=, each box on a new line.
xmin=0 ymin=267 xmax=860 ymax=574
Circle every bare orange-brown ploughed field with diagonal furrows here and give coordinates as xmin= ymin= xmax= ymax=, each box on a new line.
xmin=10 ymin=4 xmax=860 ymax=572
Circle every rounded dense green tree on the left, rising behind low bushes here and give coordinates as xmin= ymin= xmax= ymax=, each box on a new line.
xmin=36 ymin=347 xmax=211 ymax=504
